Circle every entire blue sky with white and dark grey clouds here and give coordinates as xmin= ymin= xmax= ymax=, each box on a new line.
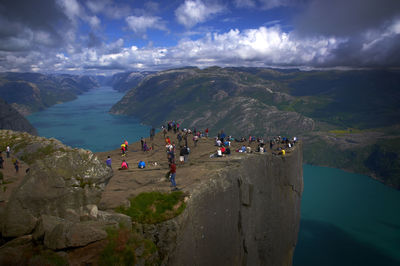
xmin=0 ymin=0 xmax=400 ymax=74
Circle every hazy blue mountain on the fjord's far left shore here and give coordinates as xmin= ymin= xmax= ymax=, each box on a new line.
xmin=0 ymin=73 xmax=99 ymax=115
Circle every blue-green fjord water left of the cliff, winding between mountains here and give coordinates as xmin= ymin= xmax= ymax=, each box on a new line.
xmin=28 ymin=87 xmax=150 ymax=152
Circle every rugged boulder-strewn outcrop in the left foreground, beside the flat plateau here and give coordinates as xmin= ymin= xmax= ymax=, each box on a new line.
xmin=0 ymin=130 xmax=131 ymax=265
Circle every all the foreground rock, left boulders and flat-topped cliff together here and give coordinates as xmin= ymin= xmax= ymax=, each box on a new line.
xmin=0 ymin=131 xmax=303 ymax=265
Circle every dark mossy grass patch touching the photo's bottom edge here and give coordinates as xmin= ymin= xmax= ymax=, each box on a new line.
xmin=99 ymin=228 xmax=159 ymax=266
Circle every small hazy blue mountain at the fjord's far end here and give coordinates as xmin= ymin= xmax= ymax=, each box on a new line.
xmin=107 ymin=71 xmax=154 ymax=92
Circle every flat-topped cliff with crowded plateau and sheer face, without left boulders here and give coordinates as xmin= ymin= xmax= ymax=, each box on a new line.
xmin=98 ymin=132 xmax=303 ymax=265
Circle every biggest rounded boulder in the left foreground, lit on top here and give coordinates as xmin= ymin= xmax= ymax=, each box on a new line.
xmin=2 ymin=148 xmax=112 ymax=237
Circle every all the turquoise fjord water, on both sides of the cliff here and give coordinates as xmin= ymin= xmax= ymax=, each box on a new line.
xmin=28 ymin=87 xmax=400 ymax=266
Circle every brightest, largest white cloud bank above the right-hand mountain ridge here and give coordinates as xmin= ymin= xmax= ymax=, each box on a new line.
xmin=170 ymin=27 xmax=342 ymax=66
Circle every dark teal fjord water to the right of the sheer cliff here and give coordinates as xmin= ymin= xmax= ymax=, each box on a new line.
xmin=293 ymin=165 xmax=400 ymax=266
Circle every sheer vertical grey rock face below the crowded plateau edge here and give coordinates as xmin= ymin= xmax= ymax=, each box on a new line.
xmin=168 ymin=143 xmax=303 ymax=265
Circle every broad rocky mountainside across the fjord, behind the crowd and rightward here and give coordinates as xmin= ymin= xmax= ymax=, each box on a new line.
xmin=110 ymin=67 xmax=400 ymax=188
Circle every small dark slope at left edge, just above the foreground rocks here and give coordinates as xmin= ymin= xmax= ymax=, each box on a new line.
xmin=0 ymin=98 xmax=37 ymax=135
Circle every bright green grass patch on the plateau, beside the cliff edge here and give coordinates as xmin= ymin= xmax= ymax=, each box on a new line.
xmin=116 ymin=191 xmax=186 ymax=224
